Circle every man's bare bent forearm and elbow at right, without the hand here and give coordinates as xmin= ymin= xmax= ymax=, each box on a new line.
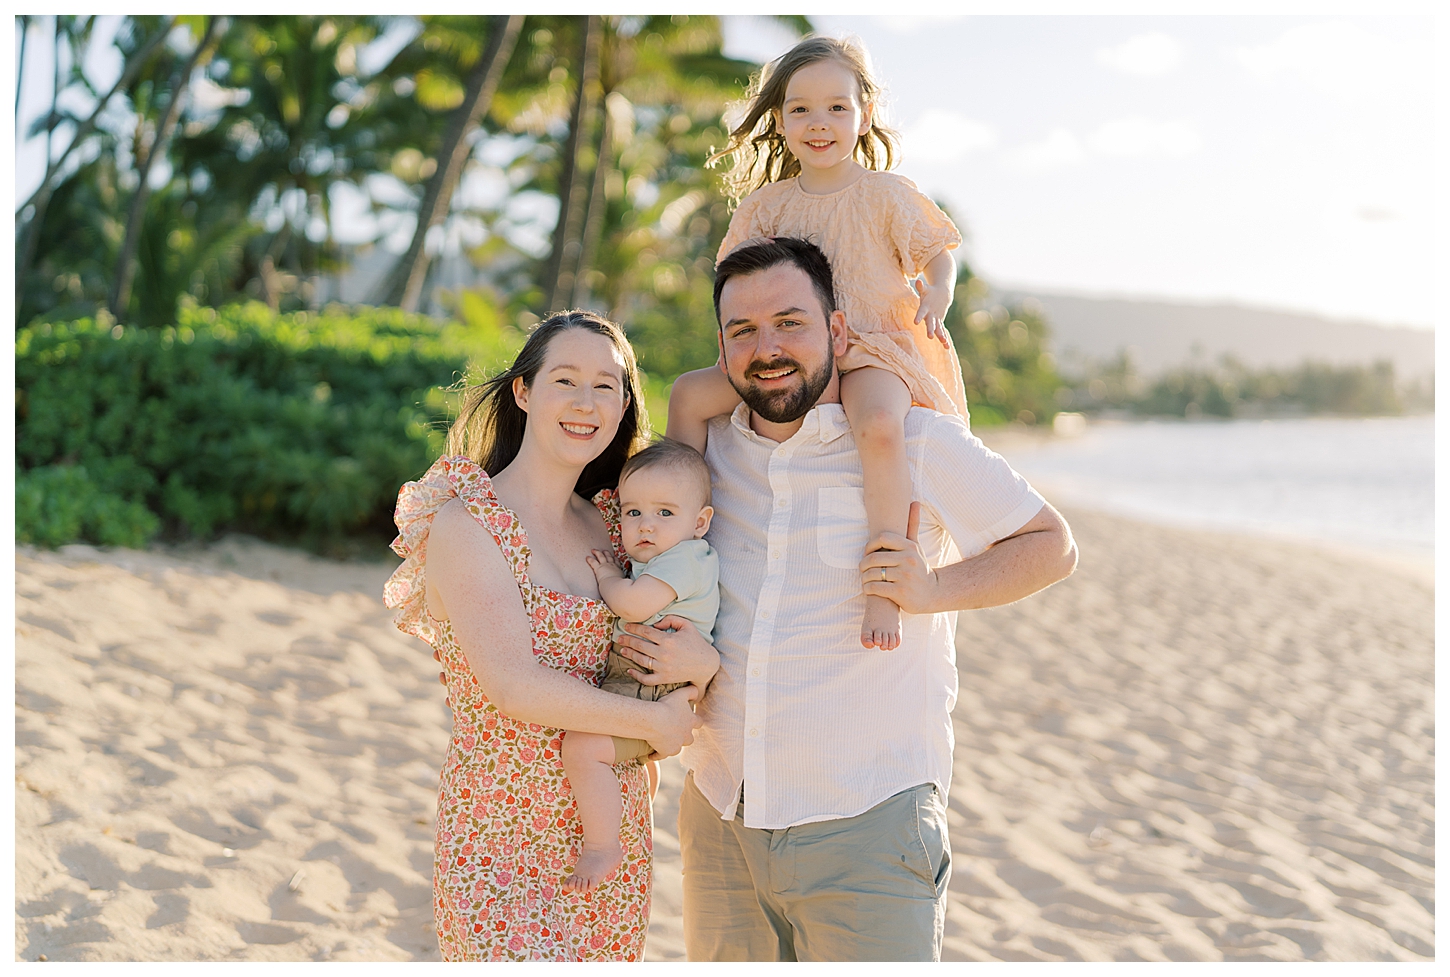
xmin=931 ymin=506 xmax=1077 ymax=612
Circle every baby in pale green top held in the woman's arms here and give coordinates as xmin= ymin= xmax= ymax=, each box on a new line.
xmin=563 ymin=439 xmax=719 ymax=890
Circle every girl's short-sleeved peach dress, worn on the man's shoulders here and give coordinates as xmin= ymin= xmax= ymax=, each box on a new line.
xmin=716 ymin=170 xmax=967 ymax=420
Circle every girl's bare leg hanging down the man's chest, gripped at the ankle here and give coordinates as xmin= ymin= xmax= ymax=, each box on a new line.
xmin=841 ymin=367 xmax=911 ymax=651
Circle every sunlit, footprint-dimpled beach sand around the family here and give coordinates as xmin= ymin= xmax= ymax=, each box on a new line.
xmin=16 ymin=512 xmax=1434 ymax=961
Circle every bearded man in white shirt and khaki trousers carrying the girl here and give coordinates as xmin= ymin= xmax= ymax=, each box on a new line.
xmin=617 ymin=238 xmax=1077 ymax=960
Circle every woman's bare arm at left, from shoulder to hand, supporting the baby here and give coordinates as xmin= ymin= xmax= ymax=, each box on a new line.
xmin=426 ymin=500 xmax=699 ymax=755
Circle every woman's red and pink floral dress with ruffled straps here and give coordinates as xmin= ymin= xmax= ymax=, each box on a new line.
xmin=384 ymin=457 xmax=653 ymax=961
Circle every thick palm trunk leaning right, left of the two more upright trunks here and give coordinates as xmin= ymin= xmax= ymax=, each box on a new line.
xmin=384 ymin=13 xmax=523 ymax=312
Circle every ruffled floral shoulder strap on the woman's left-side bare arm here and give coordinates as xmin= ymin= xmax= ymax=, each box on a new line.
xmin=383 ymin=455 xmax=524 ymax=644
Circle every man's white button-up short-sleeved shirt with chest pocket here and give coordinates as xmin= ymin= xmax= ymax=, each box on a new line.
xmin=683 ymin=404 xmax=1043 ymax=828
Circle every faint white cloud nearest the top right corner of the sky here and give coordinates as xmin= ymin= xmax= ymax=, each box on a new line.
xmin=1231 ymin=20 xmax=1409 ymax=100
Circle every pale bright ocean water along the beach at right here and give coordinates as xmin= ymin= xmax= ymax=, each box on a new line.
xmin=989 ymin=416 xmax=1436 ymax=562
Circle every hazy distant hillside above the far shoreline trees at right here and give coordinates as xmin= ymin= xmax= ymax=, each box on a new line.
xmin=995 ymin=288 xmax=1436 ymax=380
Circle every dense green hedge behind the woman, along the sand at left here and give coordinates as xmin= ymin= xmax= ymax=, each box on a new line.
xmin=16 ymin=303 xmax=522 ymax=545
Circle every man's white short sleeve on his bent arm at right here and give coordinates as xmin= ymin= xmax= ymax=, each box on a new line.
xmin=908 ymin=407 xmax=1045 ymax=560
